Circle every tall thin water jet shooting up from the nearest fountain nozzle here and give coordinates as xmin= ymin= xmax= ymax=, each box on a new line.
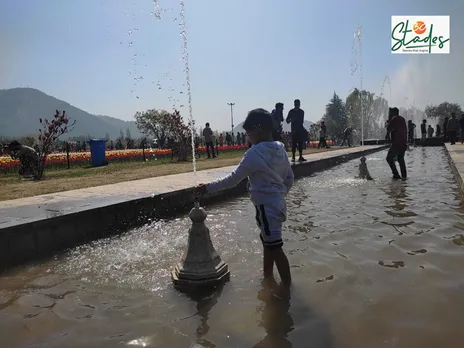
xmin=179 ymin=0 xmax=198 ymax=185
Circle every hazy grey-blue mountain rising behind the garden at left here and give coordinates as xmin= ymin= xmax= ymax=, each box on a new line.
xmin=0 ymin=88 xmax=142 ymax=139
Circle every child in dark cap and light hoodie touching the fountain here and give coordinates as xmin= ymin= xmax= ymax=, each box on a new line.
xmin=197 ymin=109 xmax=293 ymax=287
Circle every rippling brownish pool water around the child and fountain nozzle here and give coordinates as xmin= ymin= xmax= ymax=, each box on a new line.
xmin=0 ymin=148 xmax=464 ymax=348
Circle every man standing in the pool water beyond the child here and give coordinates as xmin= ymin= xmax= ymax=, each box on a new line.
xmin=387 ymin=108 xmax=408 ymax=180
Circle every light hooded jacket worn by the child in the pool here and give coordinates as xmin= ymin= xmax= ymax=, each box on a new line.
xmin=206 ymin=141 xmax=294 ymax=205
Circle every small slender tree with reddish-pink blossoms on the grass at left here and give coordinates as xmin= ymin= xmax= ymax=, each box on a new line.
xmin=36 ymin=110 xmax=76 ymax=180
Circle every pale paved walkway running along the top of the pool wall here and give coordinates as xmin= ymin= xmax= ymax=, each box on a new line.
xmin=0 ymin=145 xmax=382 ymax=229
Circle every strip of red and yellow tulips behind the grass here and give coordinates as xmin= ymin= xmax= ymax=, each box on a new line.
xmin=0 ymin=145 xmax=248 ymax=173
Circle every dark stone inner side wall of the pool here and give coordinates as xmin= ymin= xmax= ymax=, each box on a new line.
xmin=0 ymin=146 xmax=387 ymax=272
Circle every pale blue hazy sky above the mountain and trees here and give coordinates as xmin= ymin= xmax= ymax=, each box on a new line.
xmin=0 ymin=0 xmax=464 ymax=129
